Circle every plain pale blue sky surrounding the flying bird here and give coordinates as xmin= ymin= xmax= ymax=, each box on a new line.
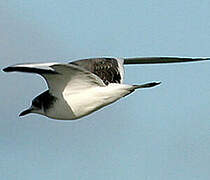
xmin=0 ymin=0 xmax=210 ymax=180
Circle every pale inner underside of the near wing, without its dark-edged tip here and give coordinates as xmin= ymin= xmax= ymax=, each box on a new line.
xmin=44 ymin=64 xmax=105 ymax=93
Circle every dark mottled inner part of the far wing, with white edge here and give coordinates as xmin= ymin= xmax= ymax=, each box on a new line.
xmin=70 ymin=58 xmax=122 ymax=85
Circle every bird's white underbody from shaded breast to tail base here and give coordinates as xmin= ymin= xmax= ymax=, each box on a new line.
xmin=45 ymin=83 xmax=133 ymax=120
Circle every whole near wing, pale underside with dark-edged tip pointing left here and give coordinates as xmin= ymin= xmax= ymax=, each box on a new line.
xmin=3 ymin=63 xmax=105 ymax=94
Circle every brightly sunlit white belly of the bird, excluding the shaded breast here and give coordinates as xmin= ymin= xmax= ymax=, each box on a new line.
xmin=64 ymin=84 xmax=130 ymax=118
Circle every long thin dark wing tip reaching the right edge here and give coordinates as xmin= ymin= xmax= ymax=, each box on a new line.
xmin=124 ymin=57 xmax=210 ymax=64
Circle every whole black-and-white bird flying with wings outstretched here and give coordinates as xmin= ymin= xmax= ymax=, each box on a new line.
xmin=3 ymin=57 xmax=210 ymax=120
